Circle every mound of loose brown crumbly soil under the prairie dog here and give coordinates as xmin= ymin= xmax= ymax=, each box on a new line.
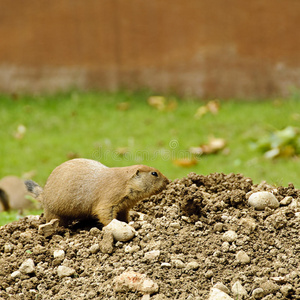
xmin=0 ymin=173 xmax=300 ymax=300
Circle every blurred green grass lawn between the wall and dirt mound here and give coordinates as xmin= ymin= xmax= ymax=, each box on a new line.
xmin=0 ymin=91 xmax=300 ymax=224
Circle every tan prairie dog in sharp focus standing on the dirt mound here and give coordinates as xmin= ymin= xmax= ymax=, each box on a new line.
xmin=26 ymin=158 xmax=169 ymax=225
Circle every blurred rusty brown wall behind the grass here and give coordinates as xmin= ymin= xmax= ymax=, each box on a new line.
xmin=0 ymin=0 xmax=300 ymax=98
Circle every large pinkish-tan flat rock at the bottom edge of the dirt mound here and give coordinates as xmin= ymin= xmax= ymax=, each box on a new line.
xmin=114 ymin=271 xmax=158 ymax=294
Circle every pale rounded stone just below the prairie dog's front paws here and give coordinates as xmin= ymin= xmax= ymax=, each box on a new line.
xmin=103 ymin=219 xmax=136 ymax=242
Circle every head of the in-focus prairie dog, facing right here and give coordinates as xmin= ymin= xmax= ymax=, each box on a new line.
xmin=128 ymin=165 xmax=169 ymax=198
